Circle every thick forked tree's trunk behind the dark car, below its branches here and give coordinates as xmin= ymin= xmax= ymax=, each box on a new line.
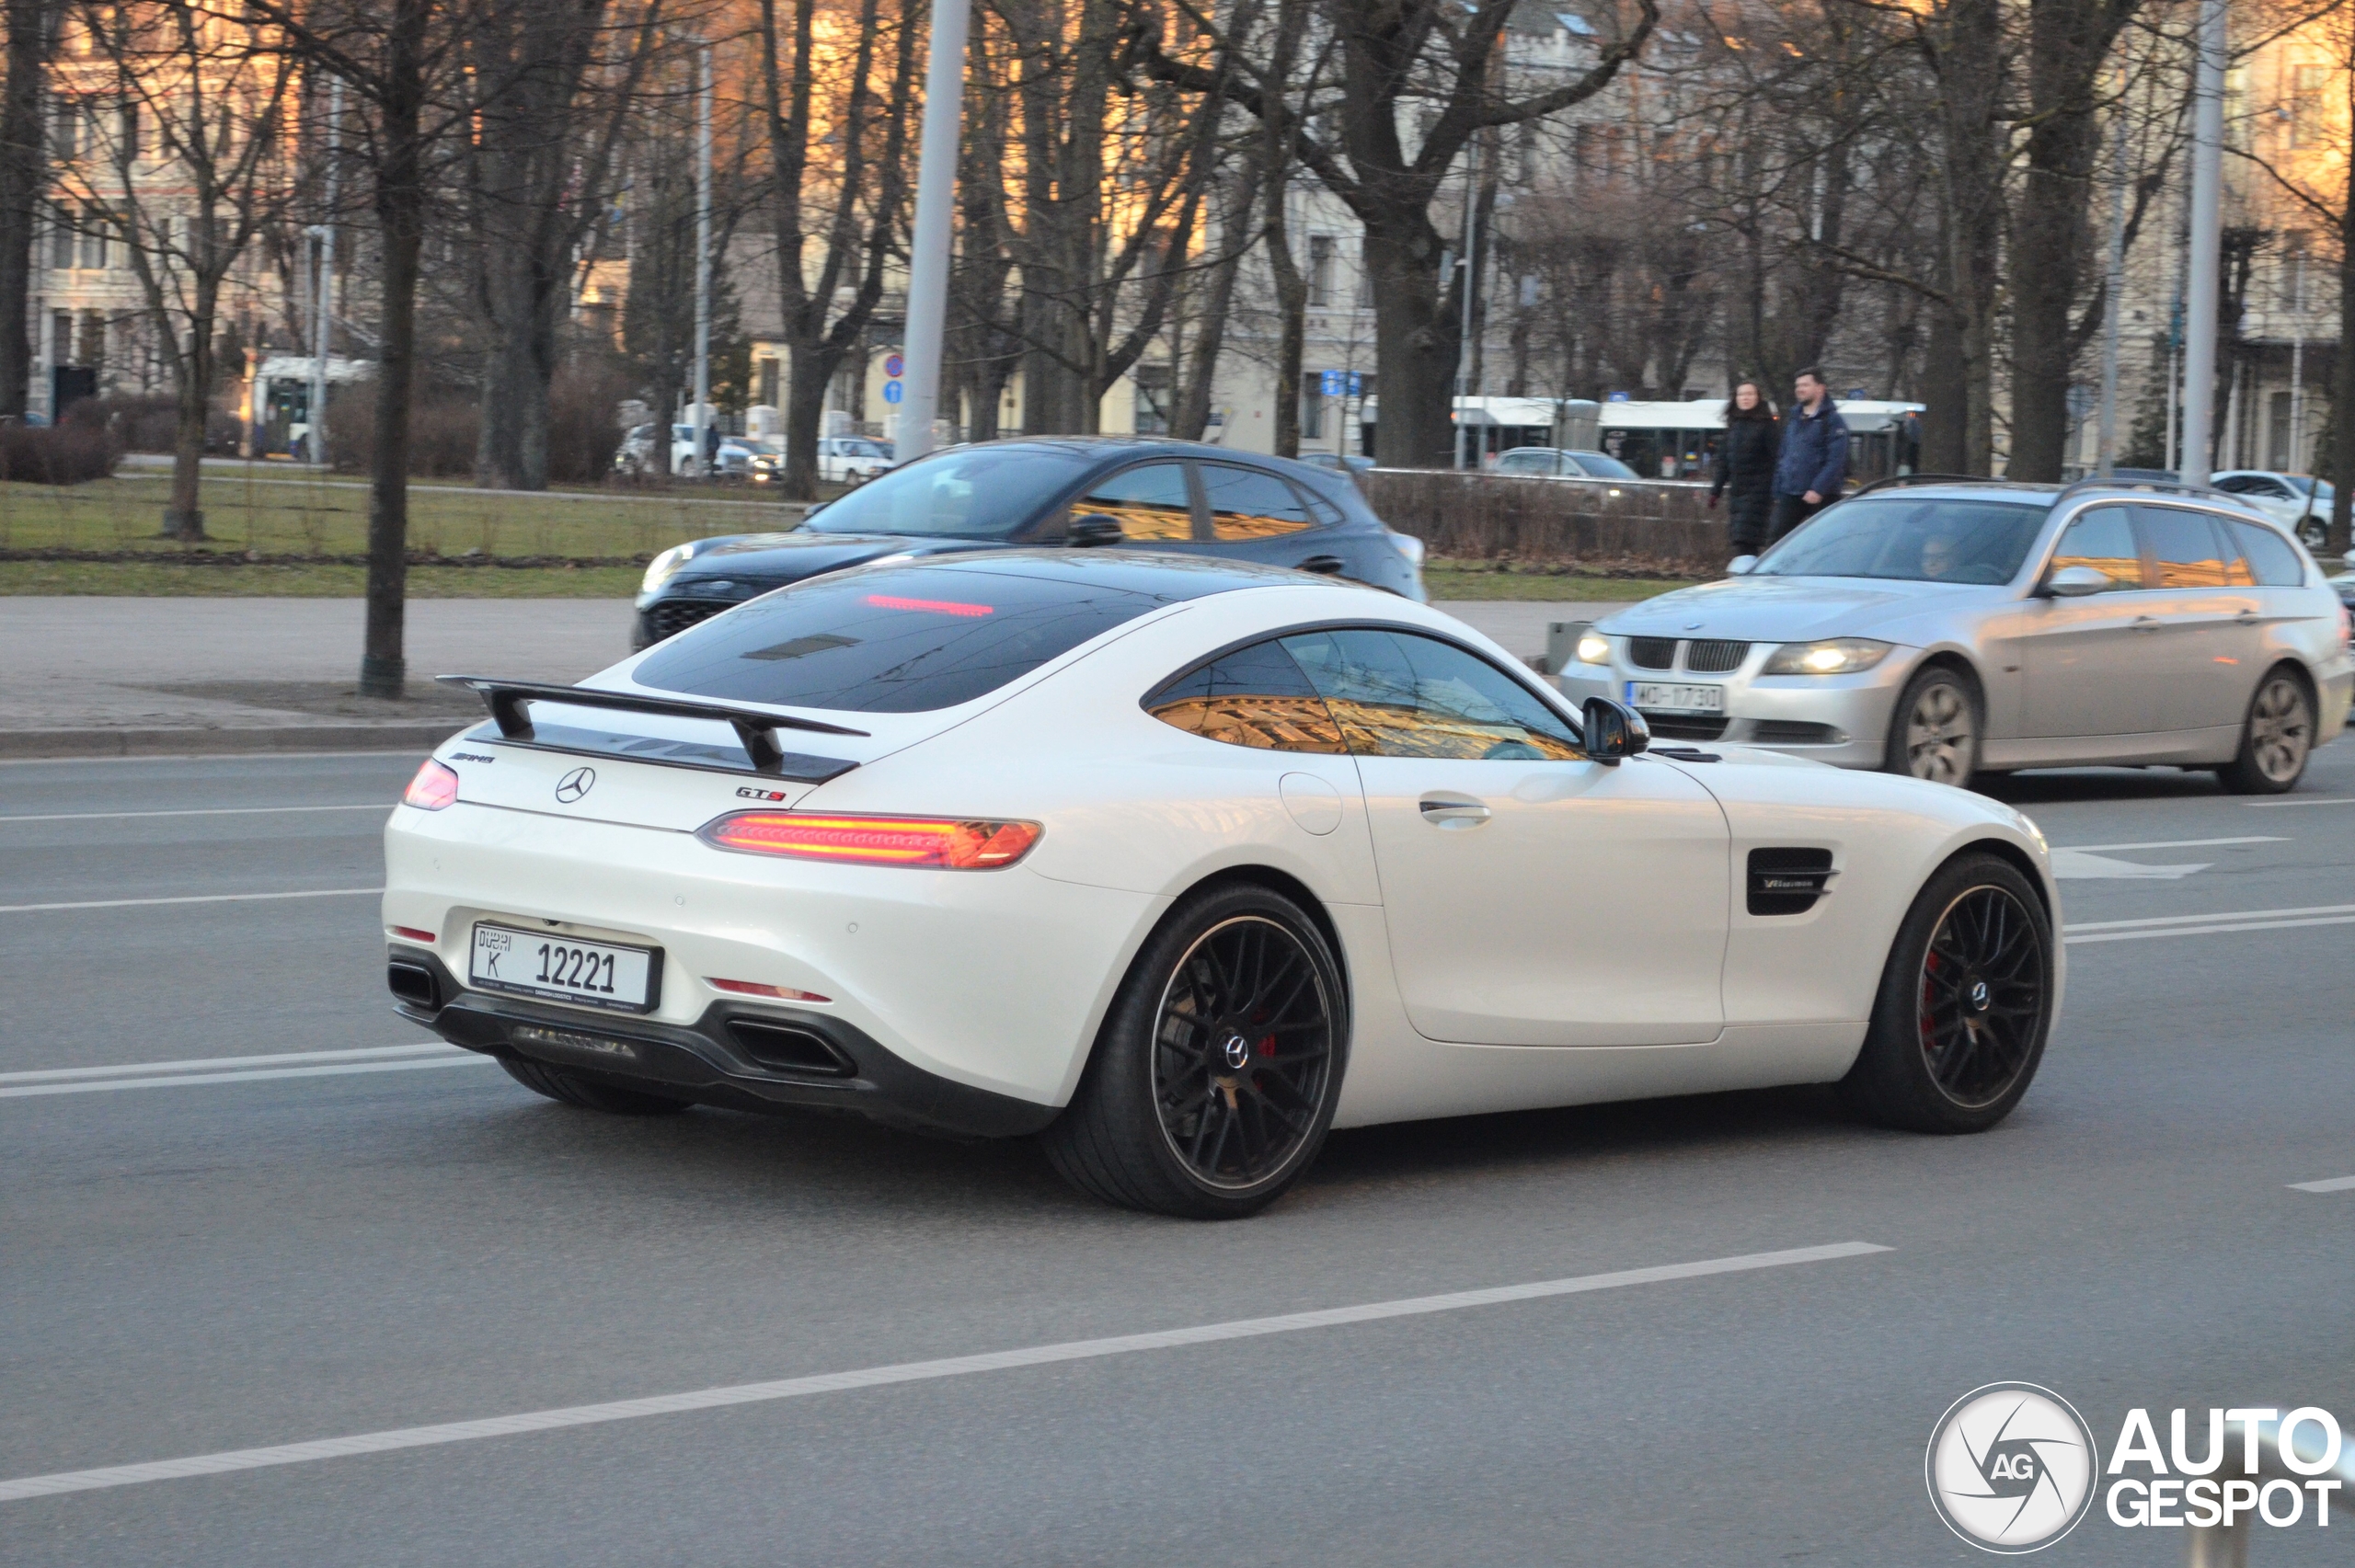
xmin=1366 ymin=207 xmax=1463 ymax=468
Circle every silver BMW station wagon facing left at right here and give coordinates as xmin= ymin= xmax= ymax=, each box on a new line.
xmin=1557 ymin=480 xmax=2355 ymax=794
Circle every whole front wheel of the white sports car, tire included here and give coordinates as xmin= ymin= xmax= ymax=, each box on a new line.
xmin=1839 ymin=850 xmax=2053 ymax=1132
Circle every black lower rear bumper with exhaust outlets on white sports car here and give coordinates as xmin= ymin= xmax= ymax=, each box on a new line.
xmin=391 ymin=944 xmax=1057 ymax=1138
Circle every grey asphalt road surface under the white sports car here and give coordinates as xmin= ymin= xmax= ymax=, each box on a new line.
xmin=0 ymin=741 xmax=2355 ymax=1568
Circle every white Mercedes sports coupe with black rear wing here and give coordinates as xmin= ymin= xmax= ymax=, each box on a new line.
xmin=384 ymin=551 xmax=2061 ymax=1218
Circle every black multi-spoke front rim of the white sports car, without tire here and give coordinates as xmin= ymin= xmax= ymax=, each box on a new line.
xmin=1917 ymin=887 xmax=2044 ymax=1109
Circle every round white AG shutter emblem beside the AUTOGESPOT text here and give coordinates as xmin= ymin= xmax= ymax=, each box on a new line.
xmin=1924 ymin=1382 xmax=2101 ymax=1556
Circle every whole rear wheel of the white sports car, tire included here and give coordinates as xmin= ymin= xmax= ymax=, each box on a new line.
xmin=1039 ymin=883 xmax=1350 ymax=1219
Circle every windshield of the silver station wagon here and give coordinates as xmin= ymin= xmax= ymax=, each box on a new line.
xmin=1754 ymin=497 xmax=2049 ymax=584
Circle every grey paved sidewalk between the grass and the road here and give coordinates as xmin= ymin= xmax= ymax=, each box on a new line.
xmin=0 ymin=596 xmax=1618 ymax=758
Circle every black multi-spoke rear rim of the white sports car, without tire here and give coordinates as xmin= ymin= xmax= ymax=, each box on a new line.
xmin=1154 ymin=916 xmax=1333 ymax=1189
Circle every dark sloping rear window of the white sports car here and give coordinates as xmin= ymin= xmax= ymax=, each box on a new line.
xmin=636 ymin=555 xmax=1241 ymax=714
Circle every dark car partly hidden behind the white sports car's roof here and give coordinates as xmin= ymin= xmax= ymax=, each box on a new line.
xmin=636 ymin=436 xmax=1425 ymax=647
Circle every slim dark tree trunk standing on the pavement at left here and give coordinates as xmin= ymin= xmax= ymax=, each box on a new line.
xmin=361 ymin=0 xmax=428 ymax=697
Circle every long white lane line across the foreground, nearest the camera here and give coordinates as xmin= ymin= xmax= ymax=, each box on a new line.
xmin=0 ymin=1241 xmax=1891 ymax=1502
